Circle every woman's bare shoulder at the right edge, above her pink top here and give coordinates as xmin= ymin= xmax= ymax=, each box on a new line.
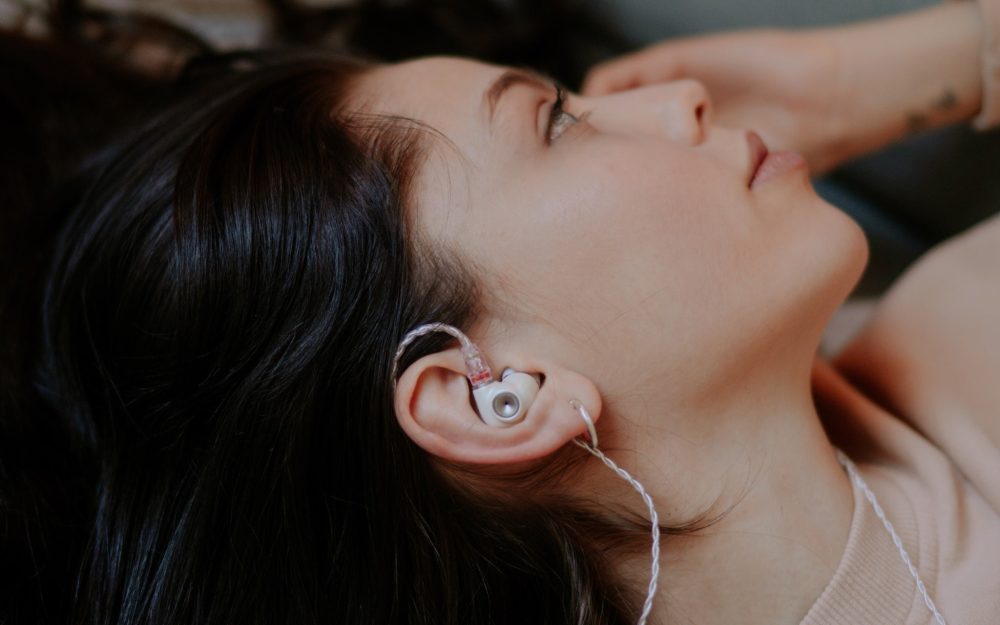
xmin=833 ymin=216 xmax=1000 ymax=460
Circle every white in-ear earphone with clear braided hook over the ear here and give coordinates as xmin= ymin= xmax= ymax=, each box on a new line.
xmin=392 ymin=323 xmax=541 ymax=427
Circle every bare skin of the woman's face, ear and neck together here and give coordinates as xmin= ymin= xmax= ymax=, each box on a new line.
xmin=372 ymin=58 xmax=867 ymax=624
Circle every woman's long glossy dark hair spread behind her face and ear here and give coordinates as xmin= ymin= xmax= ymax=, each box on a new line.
xmin=0 ymin=2 xmax=712 ymax=625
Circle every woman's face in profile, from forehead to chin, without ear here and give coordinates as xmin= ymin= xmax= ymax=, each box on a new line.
xmin=359 ymin=58 xmax=867 ymax=410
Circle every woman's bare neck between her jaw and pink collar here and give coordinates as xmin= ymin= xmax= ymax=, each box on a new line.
xmin=595 ymin=354 xmax=853 ymax=625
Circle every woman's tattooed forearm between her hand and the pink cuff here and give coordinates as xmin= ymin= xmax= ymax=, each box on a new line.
xmin=825 ymin=2 xmax=983 ymax=168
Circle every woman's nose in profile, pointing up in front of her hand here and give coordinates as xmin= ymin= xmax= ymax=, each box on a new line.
xmin=581 ymin=79 xmax=712 ymax=145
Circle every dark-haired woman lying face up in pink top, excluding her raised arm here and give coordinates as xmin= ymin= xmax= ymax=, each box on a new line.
xmin=0 ymin=5 xmax=1000 ymax=623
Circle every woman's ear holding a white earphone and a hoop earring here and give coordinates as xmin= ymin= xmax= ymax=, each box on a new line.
xmin=395 ymin=347 xmax=601 ymax=464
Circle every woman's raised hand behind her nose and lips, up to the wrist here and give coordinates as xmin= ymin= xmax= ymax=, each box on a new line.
xmin=581 ymin=30 xmax=846 ymax=174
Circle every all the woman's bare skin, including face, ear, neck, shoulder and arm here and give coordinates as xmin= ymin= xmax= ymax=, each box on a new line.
xmin=374 ymin=3 xmax=1000 ymax=624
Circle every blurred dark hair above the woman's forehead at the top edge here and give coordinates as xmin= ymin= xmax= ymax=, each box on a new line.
xmin=269 ymin=0 xmax=632 ymax=85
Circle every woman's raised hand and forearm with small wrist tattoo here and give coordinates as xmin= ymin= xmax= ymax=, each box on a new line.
xmin=582 ymin=0 xmax=984 ymax=173
